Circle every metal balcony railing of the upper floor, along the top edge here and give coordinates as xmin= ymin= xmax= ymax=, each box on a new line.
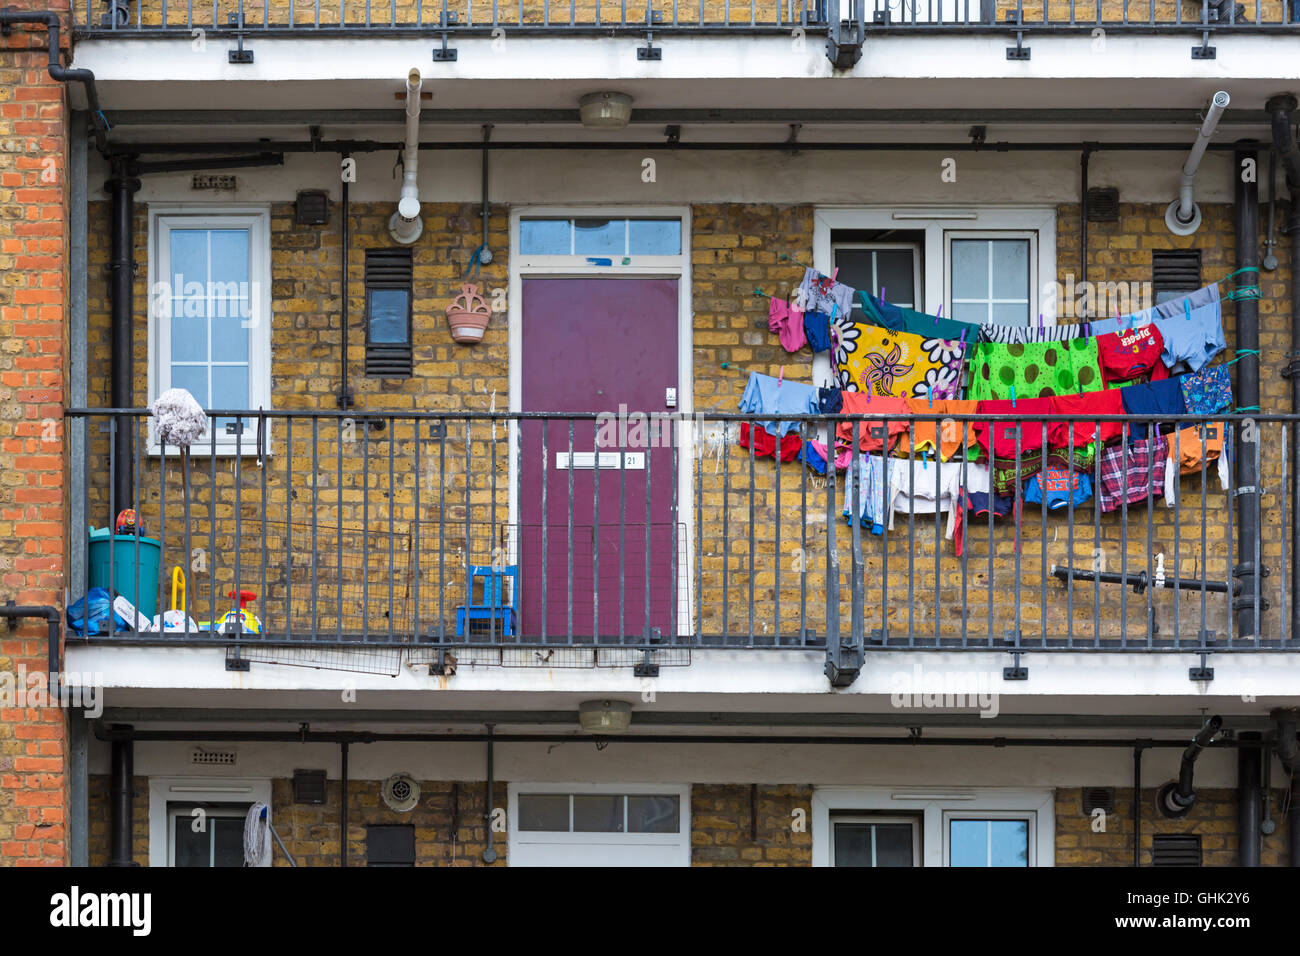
xmin=73 ymin=0 xmax=1300 ymax=37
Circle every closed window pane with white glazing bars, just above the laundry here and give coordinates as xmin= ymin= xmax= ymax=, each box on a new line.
xmin=948 ymin=233 xmax=1036 ymax=325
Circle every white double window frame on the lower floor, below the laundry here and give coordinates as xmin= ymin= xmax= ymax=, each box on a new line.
xmin=813 ymin=787 xmax=1056 ymax=866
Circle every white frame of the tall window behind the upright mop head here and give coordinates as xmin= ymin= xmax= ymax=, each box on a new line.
xmin=147 ymin=203 xmax=273 ymax=458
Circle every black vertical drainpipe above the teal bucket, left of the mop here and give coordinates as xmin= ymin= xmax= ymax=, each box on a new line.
xmin=104 ymin=157 xmax=140 ymax=512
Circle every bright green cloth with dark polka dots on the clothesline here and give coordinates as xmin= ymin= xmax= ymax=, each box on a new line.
xmin=966 ymin=337 xmax=1105 ymax=402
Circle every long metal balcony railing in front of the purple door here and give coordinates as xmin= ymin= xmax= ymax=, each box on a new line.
xmin=66 ymin=410 xmax=1300 ymax=674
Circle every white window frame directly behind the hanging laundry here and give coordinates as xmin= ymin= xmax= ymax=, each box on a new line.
xmin=813 ymin=206 xmax=1058 ymax=388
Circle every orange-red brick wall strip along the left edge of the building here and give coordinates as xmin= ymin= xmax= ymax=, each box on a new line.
xmin=0 ymin=0 xmax=68 ymax=865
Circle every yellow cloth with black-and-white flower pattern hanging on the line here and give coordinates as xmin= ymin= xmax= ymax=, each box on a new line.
xmin=837 ymin=323 xmax=966 ymax=398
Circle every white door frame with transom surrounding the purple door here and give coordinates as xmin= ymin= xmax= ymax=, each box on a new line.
xmin=506 ymin=204 xmax=696 ymax=632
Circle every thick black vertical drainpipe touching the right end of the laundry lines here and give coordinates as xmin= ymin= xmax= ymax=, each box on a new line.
xmin=1232 ymin=141 xmax=1264 ymax=637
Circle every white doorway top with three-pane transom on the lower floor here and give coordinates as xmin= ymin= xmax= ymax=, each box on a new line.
xmin=508 ymin=784 xmax=690 ymax=866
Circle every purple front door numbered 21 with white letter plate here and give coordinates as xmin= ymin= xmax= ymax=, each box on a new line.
xmin=516 ymin=278 xmax=681 ymax=643
